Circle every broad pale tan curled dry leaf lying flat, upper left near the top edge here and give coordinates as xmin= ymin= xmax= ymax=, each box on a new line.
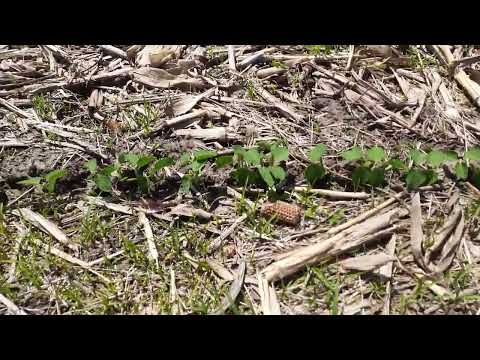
xmin=132 ymin=67 xmax=209 ymax=90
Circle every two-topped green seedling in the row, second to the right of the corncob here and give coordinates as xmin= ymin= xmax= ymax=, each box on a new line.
xmin=342 ymin=146 xmax=387 ymax=188
